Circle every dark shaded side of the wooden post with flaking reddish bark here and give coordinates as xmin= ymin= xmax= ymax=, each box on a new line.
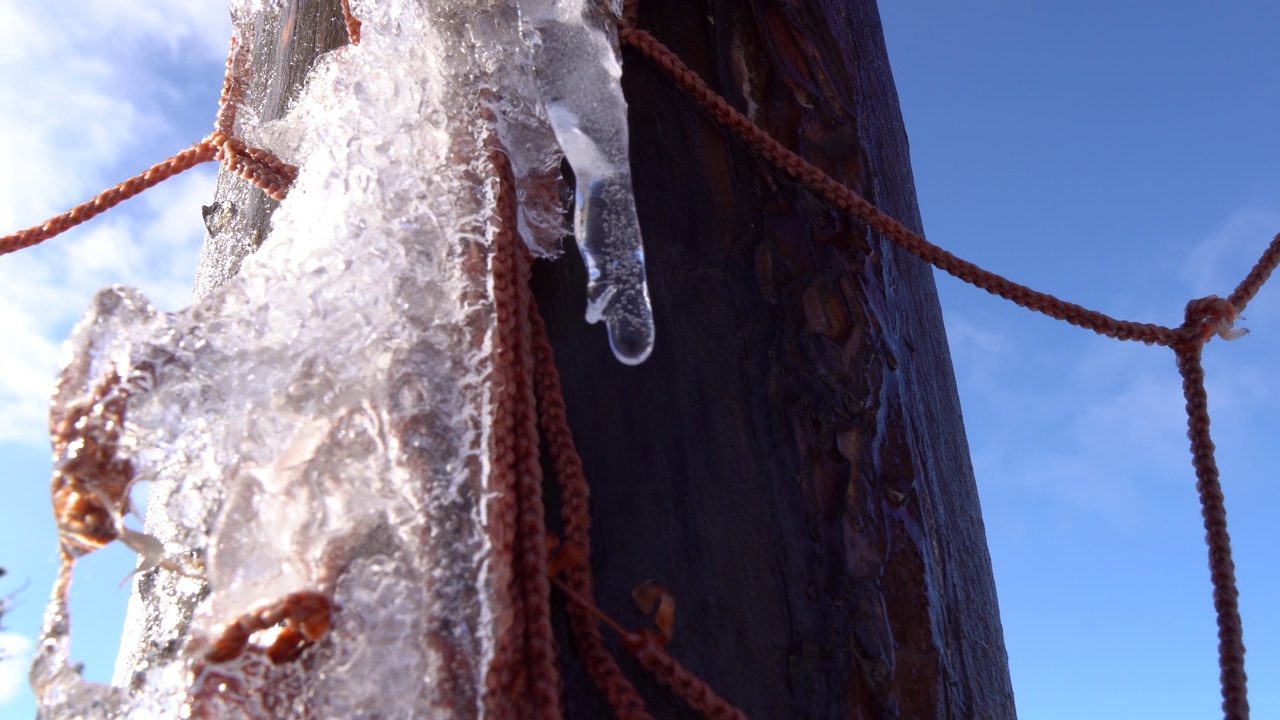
xmin=535 ymin=0 xmax=1014 ymax=719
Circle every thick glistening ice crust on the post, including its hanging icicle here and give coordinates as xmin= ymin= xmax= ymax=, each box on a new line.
xmin=32 ymin=0 xmax=653 ymax=719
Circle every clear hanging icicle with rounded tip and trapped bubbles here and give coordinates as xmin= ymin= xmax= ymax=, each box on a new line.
xmin=518 ymin=0 xmax=654 ymax=365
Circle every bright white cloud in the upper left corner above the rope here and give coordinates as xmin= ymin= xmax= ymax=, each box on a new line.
xmin=0 ymin=0 xmax=230 ymax=226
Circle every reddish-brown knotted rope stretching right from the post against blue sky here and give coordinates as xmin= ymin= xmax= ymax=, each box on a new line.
xmin=618 ymin=7 xmax=1280 ymax=720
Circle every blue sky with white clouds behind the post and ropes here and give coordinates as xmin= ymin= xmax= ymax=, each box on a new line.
xmin=0 ymin=0 xmax=1280 ymax=720
